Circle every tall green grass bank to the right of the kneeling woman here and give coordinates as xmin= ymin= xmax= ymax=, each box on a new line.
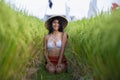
xmin=66 ymin=10 xmax=120 ymax=80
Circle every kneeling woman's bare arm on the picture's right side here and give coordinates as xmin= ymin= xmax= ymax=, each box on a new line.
xmin=58 ymin=33 xmax=67 ymax=64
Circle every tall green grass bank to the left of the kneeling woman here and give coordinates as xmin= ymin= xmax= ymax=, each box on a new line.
xmin=0 ymin=1 xmax=46 ymax=80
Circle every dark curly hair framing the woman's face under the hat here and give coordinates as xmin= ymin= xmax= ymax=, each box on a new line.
xmin=48 ymin=18 xmax=63 ymax=34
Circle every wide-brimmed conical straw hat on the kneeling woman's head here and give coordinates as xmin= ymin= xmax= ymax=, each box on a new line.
xmin=45 ymin=16 xmax=68 ymax=29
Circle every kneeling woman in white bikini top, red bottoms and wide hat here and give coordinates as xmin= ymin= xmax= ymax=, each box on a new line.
xmin=44 ymin=16 xmax=68 ymax=73
